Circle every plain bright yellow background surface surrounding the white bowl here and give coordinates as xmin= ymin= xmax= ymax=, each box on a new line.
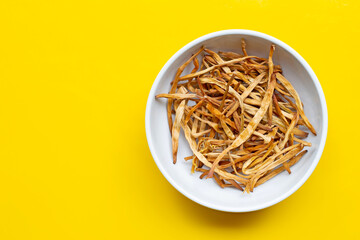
xmin=0 ymin=0 xmax=360 ymax=240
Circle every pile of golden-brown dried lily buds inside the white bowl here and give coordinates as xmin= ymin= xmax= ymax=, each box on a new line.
xmin=156 ymin=41 xmax=316 ymax=192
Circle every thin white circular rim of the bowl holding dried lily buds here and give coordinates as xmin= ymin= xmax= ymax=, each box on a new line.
xmin=145 ymin=29 xmax=328 ymax=212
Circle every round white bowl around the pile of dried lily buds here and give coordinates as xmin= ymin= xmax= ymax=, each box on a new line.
xmin=145 ymin=29 xmax=328 ymax=212
